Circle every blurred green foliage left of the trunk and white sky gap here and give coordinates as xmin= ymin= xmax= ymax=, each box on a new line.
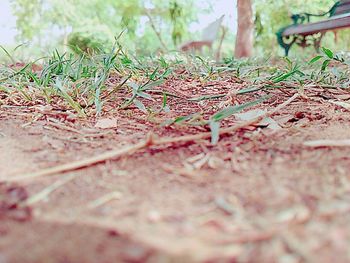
xmin=11 ymin=0 xmax=202 ymax=54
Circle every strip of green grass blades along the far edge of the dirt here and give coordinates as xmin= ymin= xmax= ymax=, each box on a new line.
xmin=0 ymin=44 xmax=350 ymax=143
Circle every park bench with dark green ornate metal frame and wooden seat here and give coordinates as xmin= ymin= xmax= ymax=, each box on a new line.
xmin=276 ymin=0 xmax=350 ymax=56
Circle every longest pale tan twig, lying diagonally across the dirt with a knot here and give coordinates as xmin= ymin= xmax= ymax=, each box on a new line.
xmin=3 ymin=93 xmax=299 ymax=182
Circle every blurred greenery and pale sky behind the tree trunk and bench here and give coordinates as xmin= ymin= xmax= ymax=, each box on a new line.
xmin=0 ymin=0 xmax=350 ymax=59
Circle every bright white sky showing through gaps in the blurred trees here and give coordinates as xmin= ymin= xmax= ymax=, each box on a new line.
xmin=0 ymin=0 xmax=237 ymax=46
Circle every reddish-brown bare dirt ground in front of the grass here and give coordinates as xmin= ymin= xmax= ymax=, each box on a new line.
xmin=0 ymin=79 xmax=350 ymax=263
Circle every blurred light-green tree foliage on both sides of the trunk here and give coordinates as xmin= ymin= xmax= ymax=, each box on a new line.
xmin=11 ymin=0 xmax=350 ymax=57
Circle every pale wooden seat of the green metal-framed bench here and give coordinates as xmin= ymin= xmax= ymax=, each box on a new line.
xmin=282 ymin=13 xmax=350 ymax=36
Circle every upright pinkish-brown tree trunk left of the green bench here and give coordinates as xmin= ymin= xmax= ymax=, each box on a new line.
xmin=235 ymin=0 xmax=254 ymax=58
